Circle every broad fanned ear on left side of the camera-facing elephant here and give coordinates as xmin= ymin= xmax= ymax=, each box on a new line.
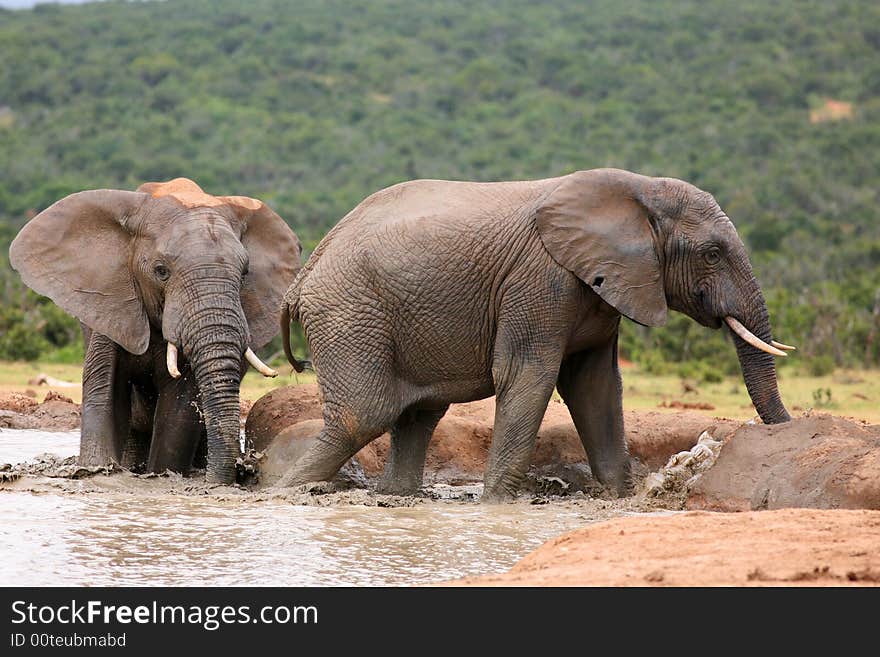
xmin=9 ymin=189 xmax=150 ymax=354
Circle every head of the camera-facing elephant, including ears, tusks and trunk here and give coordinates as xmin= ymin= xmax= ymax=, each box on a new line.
xmin=10 ymin=178 xmax=301 ymax=483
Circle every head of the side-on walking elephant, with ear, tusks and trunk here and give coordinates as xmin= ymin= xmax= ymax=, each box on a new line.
xmin=537 ymin=169 xmax=793 ymax=424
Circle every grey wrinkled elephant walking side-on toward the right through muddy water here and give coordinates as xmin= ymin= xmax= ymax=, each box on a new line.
xmin=281 ymin=169 xmax=790 ymax=500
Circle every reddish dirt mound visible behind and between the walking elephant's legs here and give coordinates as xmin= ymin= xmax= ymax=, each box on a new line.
xmin=245 ymin=385 xmax=738 ymax=490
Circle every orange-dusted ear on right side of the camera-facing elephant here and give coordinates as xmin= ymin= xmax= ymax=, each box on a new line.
xmin=223 ymin=196 xmax=302 ymax=349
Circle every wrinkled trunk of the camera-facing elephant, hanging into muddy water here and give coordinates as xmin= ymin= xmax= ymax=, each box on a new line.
xmin=166 ymin=276 xmax=248 ymax=484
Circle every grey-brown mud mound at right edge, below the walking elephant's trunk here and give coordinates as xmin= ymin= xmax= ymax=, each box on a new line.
xmin=687 ymin=415 xmax=880 ymax=511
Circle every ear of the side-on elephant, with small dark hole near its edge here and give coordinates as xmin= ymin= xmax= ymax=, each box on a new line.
xmin=536 ymin=169 xmax=667 ymax=326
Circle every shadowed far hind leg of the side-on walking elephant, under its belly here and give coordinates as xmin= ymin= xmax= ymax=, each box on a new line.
xmin=379 ymin=406 xmax=449 ymax=495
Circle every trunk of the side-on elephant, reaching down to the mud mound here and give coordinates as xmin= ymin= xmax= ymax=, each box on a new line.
xmin=731 ymin=285 xmax=791 ymax=424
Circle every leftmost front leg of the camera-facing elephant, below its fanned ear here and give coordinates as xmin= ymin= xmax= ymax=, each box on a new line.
xmin=79 ymin=332 xmax=131 ymax=465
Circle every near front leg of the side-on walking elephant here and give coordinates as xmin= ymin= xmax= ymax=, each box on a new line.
xmin=482 ymin=349 xmax=557 ymax=502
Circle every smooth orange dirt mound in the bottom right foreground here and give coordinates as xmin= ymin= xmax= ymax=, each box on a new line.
xmin=451 ymin=509 xmax=880 ymax=586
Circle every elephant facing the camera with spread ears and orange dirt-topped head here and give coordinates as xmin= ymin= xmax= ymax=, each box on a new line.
xmin=10 ymin=178 xmax=302 ymax=484
